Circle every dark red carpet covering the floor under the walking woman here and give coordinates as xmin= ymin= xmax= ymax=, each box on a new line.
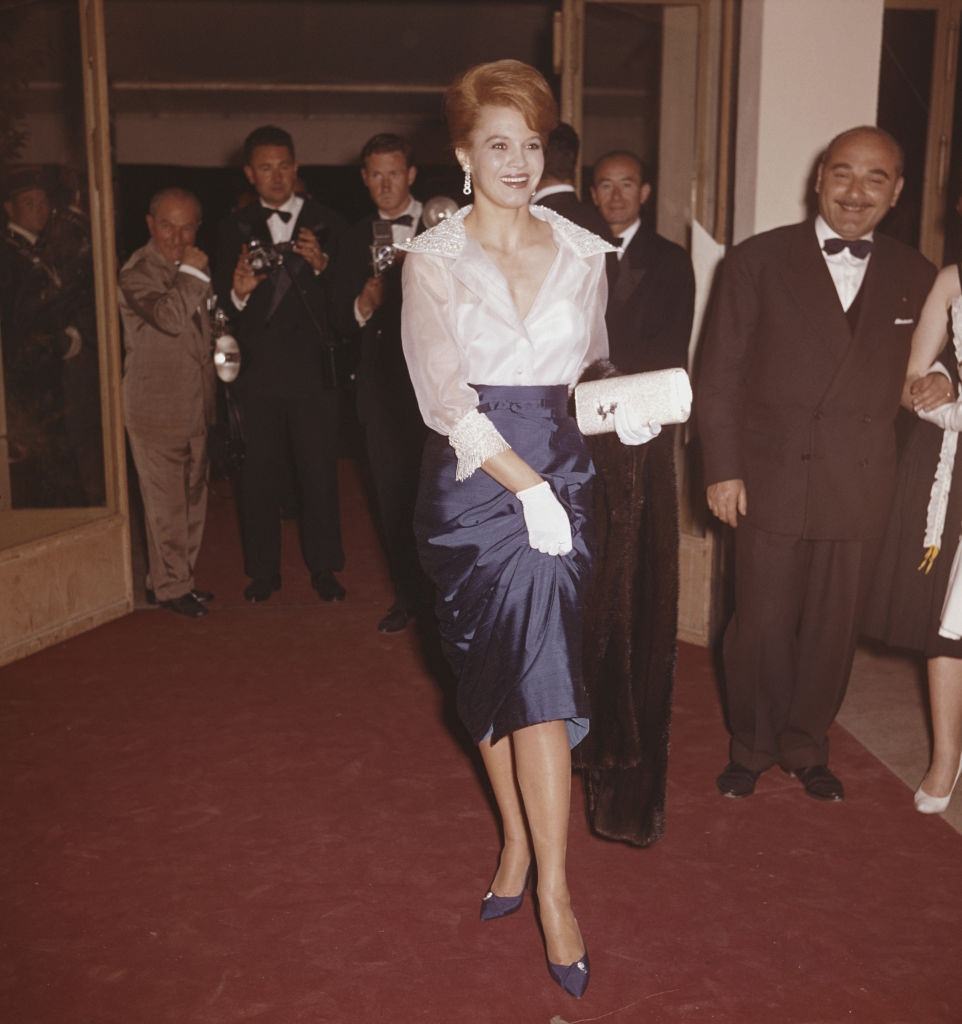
xmin=0 ymin=464 xmax=962 ymax=1024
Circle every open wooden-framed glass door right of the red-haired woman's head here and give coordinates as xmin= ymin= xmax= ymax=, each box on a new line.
xmin=554 ymin=0 xmax=737 ymax=644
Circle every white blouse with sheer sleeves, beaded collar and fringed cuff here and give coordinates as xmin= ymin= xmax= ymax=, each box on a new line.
xmin=398 ymin=206 xmax=615 ymax=479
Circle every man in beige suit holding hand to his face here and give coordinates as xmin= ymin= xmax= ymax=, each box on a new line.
xmin=120 ymin=188 xmax=214 ymax=618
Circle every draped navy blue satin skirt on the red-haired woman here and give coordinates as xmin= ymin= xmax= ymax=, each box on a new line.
xmin=414 ymin=385 xmax=594 ymax=746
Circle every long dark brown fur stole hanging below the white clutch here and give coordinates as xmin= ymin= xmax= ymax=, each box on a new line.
xmin=575 ymin=361 xmax=678 ymax=846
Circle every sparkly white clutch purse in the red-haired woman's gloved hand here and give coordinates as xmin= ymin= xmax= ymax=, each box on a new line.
xmin=575 ymin=367 xmax=692 ymax=434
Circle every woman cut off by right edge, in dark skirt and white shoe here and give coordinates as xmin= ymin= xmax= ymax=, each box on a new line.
xmin=866 ymin=266 xmax=962 ymax=814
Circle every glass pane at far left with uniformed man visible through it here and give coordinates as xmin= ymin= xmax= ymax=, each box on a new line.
xmin=0 ymin=0 xmax=107 ymax=547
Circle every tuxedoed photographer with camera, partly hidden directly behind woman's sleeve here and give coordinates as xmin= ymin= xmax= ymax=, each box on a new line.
xmin=335 ymin=134 xmax=424 ymax=633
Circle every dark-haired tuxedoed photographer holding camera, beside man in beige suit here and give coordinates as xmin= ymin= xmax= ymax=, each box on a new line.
xmin=214 ymin=125 xmax=344 ymax=602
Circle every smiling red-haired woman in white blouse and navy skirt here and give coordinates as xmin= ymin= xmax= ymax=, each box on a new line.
xmin=402 ymin=60 xmax=657 ymax=996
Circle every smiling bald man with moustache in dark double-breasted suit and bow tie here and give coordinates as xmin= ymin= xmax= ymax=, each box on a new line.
xmin=695 ymin=127 xmax=947 ymax=801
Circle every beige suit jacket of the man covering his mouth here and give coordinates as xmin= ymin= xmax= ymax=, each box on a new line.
xmin=120 ymin=242 xmax=215 ymax=438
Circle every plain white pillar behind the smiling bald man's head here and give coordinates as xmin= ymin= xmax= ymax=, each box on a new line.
xmin=735 ymin=0 xmax=885 ymax=242
